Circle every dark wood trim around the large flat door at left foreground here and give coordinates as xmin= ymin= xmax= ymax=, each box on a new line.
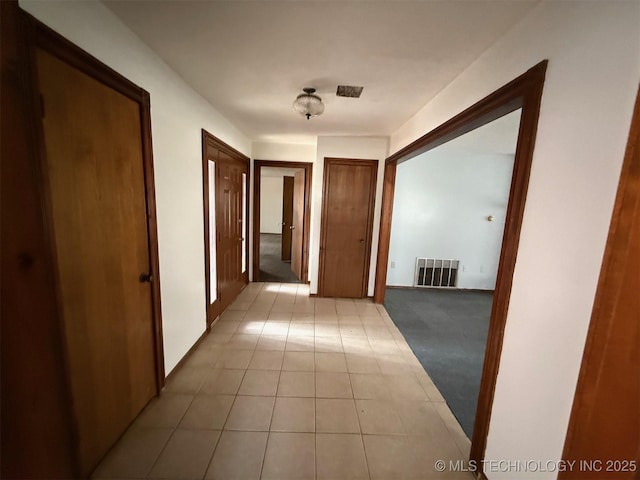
xmin=23 ymin=13 xmax=165 ymax=394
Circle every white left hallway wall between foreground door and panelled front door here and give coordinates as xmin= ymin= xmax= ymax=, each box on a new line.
xmin=20 ymin=0 xmax=251 ymax=373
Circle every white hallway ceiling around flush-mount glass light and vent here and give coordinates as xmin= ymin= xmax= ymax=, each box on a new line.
xmin=105 ymin=0 xmax=538 ymax=143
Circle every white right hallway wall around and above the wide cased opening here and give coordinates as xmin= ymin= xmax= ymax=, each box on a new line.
xmin=391 ymin=1 xmax=640 ymax=479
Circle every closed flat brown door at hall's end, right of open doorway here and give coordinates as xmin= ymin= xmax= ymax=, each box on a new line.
xmin=318 ymin=158 xmax=378 ymax=298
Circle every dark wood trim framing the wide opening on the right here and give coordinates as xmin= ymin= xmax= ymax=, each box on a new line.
xmin=373 ymin=60 xmax=548 ymax=476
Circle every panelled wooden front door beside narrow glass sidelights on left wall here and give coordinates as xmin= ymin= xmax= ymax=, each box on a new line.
xmin=216 ymin=151 xmax=248 ymax=311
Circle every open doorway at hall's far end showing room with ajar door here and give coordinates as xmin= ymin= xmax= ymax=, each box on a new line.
xmin=253 ymin=160 xmax=311 ymax=283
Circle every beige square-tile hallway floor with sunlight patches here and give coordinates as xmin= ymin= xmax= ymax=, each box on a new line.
xmin=93 ymin=283 xmax=473 ymax=480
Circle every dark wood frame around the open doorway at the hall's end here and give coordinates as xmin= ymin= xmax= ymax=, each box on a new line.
xmin=251 ymin=160 xmax=313 ymax=283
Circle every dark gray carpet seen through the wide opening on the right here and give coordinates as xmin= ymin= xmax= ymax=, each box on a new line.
xmin=384 ymin=288 xmax=493 ymax=438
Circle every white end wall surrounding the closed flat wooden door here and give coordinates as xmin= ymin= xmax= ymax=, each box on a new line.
xmin=309 ymin=137 xmax=389 ymax=296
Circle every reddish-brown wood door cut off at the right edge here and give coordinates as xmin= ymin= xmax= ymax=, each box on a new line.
xmin=558 ymin=87 xmax=640 ymax=480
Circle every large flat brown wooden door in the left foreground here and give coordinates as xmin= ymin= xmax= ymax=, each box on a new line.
xmin=37 ymin=50 xmax=157 ymax=475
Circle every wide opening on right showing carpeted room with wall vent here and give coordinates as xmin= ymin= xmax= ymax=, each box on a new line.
xmin=385 ymin=109 xmax=521 ymax=437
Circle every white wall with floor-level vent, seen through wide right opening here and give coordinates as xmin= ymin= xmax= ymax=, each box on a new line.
xmin=387 ymin=110 xmax=520 ymax=290
